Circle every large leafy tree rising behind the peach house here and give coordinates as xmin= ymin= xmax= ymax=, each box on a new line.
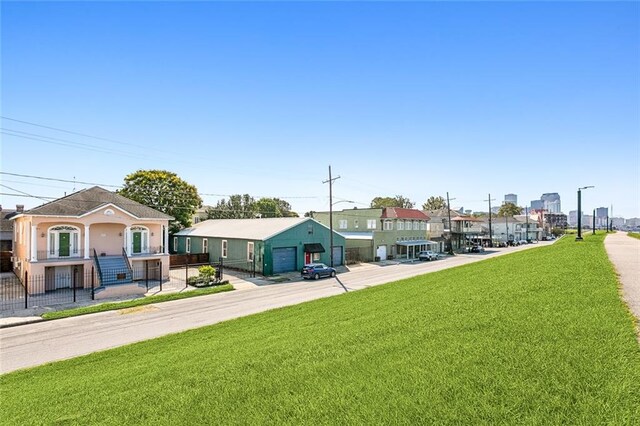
xmin=117 ymin=170 xmax=202 ymax=233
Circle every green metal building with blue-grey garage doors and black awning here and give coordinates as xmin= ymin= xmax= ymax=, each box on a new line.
xmin=172 ymin=217 xmax=345 ymax=275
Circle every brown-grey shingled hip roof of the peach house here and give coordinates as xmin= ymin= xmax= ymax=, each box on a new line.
xmin=24 ymin=186 xmax=173 ymax=220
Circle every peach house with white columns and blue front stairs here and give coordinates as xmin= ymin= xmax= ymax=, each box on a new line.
xmin=12 ymin=186 xmax=173 ymax=294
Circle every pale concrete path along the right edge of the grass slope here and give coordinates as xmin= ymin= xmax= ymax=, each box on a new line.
xmin=604 ymin=232 xmax=640 ymax=340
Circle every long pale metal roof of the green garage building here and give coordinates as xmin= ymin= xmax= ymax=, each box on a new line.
xmin=174 ymin=217 xmax=318 ymax=241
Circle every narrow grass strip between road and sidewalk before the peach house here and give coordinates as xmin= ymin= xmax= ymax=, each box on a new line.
xmin=42 ymin=284 xmax=233 ymax=320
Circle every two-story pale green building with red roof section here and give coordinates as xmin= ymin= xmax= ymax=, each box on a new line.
xmin=313 ymin=207 xmax=437 ymax=263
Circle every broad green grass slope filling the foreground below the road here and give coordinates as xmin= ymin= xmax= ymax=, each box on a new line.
xmin=0 ymin=234 xmax=640 ymax=425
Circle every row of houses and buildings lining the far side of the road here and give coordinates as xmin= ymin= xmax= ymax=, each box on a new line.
xmin=3 ymin=187 xmax=540 ymax=293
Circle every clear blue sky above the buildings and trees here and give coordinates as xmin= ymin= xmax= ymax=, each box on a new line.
xmin=0 ymin=2 xmax=640 ymax=217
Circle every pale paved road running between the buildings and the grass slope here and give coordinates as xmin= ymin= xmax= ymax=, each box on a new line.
xmin=0 ymin=242 xmax=550 ymax=373
